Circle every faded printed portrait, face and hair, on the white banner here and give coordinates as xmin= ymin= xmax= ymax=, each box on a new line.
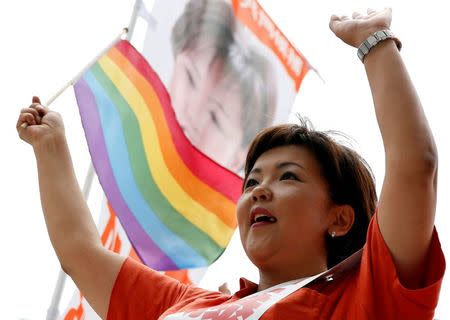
xmin=168 ymin=0 xmax=276 ymax=172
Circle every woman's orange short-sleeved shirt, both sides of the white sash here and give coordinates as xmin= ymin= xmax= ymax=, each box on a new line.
xmin=108 ymin=215 xmax=445 ymax=320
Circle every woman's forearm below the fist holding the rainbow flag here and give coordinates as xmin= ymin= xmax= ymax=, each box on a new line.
xmin=34 ymin=136 xmax=101 ymax=273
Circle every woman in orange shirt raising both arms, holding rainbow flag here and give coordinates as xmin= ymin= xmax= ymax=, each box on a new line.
xmin=17 ymin=9 xmax=445 ymax=320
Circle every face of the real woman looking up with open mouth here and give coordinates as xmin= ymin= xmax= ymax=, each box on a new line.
xmin=237 ymin=145 xmax=333 ymax=270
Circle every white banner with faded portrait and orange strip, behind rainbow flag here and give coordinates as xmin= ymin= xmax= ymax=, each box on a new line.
xmin=143 ymin=0 xmax=307 ymax=172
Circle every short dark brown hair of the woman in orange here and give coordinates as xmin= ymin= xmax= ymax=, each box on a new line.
xmin=244 ymin=117 xmax=377 ymax=268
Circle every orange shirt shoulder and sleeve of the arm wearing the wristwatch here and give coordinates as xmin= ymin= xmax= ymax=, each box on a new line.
xmin=297 ymin=215 xmax=445 ymax=319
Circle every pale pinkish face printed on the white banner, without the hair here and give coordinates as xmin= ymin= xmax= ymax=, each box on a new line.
xmin=169 ymin=50 xmax=243 ymax=170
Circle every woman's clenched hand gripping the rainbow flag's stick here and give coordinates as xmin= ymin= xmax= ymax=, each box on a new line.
xmin=16 ymin=97 xmax=64 ymax=147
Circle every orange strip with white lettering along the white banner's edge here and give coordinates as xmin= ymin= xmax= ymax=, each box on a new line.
xmin=233 ymin=0 xmax=310 ymax=91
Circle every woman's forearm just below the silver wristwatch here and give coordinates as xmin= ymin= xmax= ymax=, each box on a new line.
xmin=364 ymin=40 xmax=437 ymax=172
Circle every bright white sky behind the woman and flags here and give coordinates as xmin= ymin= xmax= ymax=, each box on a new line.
xmin=0 ymin=0 xmax=450 ymax=319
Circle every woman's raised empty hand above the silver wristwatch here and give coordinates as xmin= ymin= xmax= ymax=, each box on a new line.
xmin=330 ymin=8 xmax=392 ymax=48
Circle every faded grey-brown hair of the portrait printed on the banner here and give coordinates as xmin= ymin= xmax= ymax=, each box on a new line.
xmin=171 ymin=0 xmax=277 ymax=146
